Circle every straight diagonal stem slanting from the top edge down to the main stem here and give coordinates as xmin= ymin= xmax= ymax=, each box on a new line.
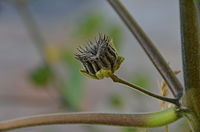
xmin=108 ymin=0 xmax=183 ymax=98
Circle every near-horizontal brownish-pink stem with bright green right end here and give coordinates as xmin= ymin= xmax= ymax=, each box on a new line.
xmin=0 ymin=108 xmax=182 ymax=131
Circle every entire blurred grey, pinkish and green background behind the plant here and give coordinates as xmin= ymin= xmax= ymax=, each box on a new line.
xmin=0 ymin=0 xmax=189 ymax=132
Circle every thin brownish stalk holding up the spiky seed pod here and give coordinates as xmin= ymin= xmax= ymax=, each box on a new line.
xmin=110 ymin=74 xmax=180 ymax=106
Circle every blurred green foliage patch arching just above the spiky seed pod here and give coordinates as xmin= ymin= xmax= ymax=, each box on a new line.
xmin=74 ymin=13 xmax=123 ymax=50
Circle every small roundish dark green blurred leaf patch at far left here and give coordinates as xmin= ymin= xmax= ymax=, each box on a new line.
xmin=29 ymin=64 xmax=54 ymax=86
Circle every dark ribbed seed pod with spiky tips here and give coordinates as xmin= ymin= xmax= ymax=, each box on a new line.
xmin=75 ymin=34 xmax=124 ymax=79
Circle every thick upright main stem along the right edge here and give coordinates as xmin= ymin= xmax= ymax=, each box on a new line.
xmin=180 ymin=0 xmax=200 ymax=132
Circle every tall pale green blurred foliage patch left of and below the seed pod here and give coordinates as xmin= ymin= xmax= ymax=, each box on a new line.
xmin=62 ymin=51 xmax=84 ymax=110
